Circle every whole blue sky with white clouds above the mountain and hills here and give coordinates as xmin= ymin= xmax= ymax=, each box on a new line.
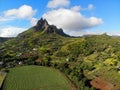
xmin=0 ymin=0 xmax=120 ymax=37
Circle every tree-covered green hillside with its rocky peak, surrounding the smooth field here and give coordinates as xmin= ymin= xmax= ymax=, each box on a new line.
xmin=0 ymin=20 xmax=120 ymax=90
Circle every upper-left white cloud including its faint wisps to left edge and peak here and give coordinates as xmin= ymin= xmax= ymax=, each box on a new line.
xmin=0 ymin=5 xmax=37 ymax=26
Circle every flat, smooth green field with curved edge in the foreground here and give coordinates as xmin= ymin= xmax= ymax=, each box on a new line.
xmin=3 ymin=66 xmax=72 ymax=90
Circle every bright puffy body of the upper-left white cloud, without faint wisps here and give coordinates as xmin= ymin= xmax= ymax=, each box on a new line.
xmin=4 ymin=5 xmax=36 ymax=19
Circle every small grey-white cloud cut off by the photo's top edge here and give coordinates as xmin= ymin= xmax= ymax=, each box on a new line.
xmin=47 ymin=0 xmax=70 ymax=8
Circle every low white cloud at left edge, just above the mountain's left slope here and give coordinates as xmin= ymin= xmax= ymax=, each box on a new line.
xmin=0 ymin=27 xmax=26 ymax=37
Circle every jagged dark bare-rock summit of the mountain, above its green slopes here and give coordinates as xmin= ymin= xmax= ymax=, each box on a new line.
xmin=34 ymin=18 xmax=69 ymax=37
